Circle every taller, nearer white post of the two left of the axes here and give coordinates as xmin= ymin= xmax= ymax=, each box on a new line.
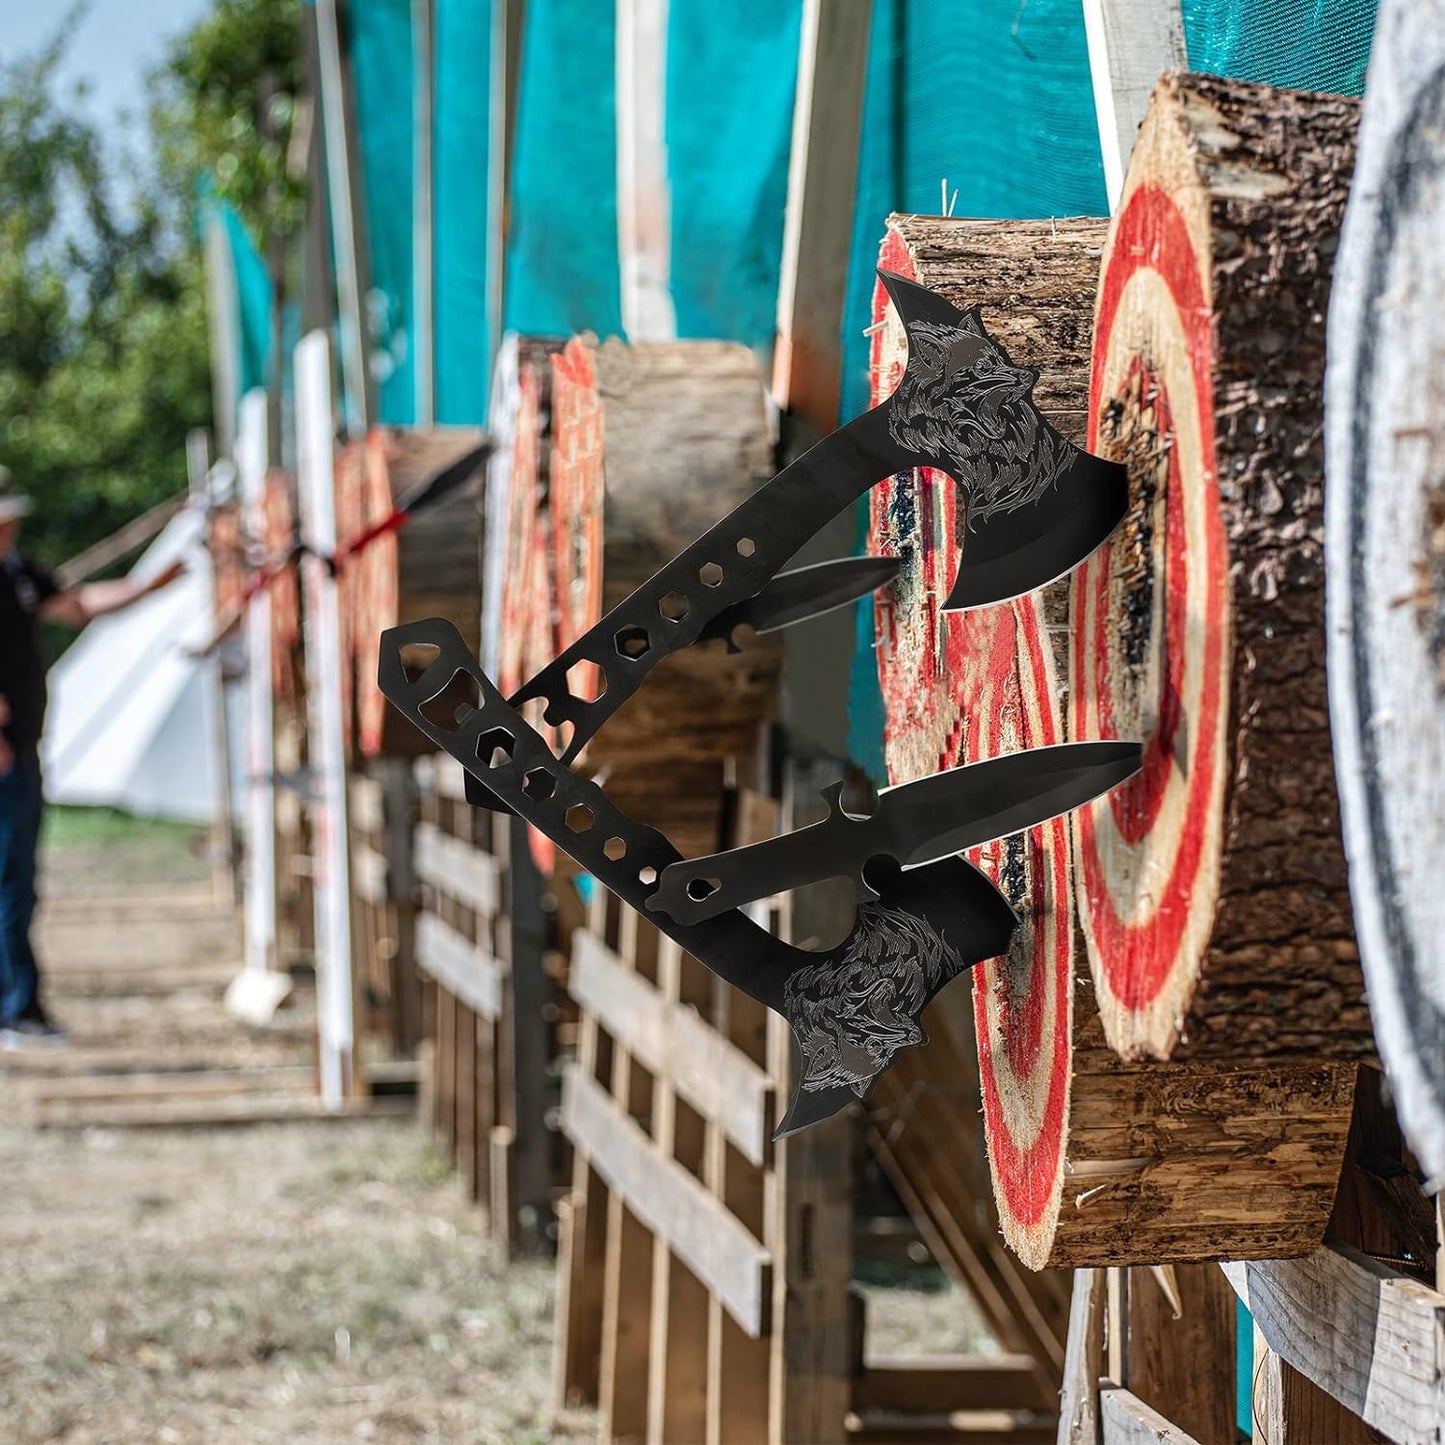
xmin=296 ymin=331 xmax=354 ymax=1107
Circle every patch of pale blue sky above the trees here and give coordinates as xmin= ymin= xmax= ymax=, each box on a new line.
xmin=0 ymin=0 xmax=211 ymax=131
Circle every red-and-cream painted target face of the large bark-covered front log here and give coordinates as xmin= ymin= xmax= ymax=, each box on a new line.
xmin=1071 ymin=186 xmax=1228 ymax=1058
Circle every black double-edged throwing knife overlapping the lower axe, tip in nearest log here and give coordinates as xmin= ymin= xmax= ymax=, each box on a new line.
xmin=647 ymin=743 xmax=1143 ymax=923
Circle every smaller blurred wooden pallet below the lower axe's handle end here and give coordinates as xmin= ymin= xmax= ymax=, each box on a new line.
xmin=412 ymin=757 xmax=555 ymax=1259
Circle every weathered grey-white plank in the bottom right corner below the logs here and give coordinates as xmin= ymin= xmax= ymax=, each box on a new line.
xmin=1221 ymin=1244 xmax=1445 ymax=1441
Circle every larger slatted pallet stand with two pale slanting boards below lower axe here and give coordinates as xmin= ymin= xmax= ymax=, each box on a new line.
xmin=553 ymin=790 xmax=1055 ymax=1445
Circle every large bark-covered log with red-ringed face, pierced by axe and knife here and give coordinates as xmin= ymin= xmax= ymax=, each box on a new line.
xmin=1071 ymin=75 xmax=1374 ymax=1064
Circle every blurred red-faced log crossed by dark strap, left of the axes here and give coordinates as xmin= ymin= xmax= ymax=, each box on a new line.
xmin=335 ymin=426 xmax=481 ymax=757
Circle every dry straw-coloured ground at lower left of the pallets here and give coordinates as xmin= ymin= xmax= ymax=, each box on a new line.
xmin=0 ymin=815 xmax=591 ymax=1445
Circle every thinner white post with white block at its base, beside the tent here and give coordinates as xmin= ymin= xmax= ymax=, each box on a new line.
xmin=236 ymin=390 xmax=277 ymax=972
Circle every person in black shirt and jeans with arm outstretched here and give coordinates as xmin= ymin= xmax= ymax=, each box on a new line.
xmin=0 ymin=467 xmax=184 ymax=1048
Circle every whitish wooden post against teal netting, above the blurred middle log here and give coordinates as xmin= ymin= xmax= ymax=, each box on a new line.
xmin=617 ymin=0 xmax=678 ymax=341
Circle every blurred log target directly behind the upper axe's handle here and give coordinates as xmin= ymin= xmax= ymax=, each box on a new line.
xmin=549 ymin=338 xmax=780 ymax=854
